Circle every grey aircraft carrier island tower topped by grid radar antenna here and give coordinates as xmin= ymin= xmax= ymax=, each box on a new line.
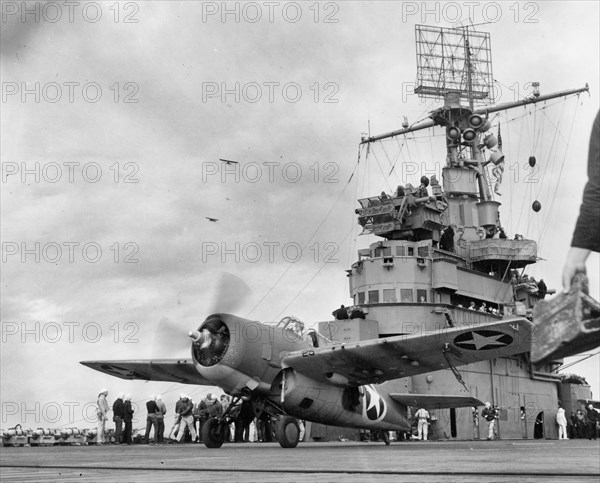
xmin=313 ymin=26 xmax=591 ymax=439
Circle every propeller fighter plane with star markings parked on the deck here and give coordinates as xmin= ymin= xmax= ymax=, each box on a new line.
xmin=81 ymin=313 xmax=531 ymax=448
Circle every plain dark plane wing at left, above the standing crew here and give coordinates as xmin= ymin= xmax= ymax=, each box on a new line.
xmin=80 ymin=359 xmax=214 ymax=386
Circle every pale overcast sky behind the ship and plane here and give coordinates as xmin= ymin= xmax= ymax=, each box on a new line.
xmin=0 ymin=1 xmax=600 ymax=428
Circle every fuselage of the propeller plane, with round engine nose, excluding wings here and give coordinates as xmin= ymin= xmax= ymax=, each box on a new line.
xmin=192 ymin=314 xmax=410 ymax=430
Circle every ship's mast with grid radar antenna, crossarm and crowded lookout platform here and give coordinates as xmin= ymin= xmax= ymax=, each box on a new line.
xmin=357 ymin=25 xmax=589 ymax=244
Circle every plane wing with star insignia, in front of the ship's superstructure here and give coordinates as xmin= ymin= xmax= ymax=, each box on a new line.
xmin=282 ymin=317 xmax=532 ymax=385
